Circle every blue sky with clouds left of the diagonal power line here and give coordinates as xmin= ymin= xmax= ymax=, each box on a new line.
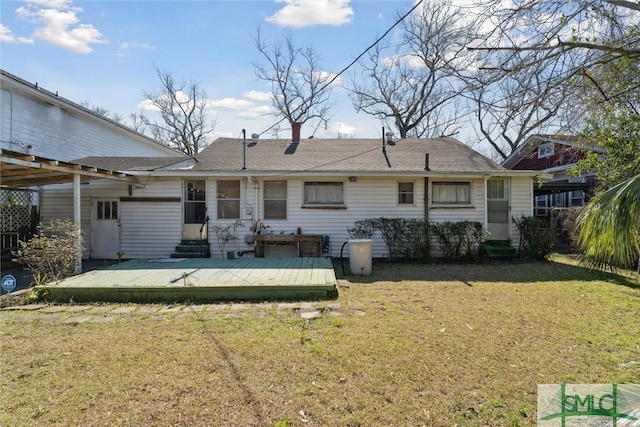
xmin=0 ymin=0 xmax=420 ymax=143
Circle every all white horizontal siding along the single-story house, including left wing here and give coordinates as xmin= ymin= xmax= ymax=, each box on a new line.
xmin=41 ymin=176 xmax=533 ymax=258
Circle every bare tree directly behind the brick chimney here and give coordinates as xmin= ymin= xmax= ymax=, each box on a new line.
xmin=253 ymin=30 xmax=333 ymax=137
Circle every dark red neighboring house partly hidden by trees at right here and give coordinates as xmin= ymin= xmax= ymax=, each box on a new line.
xmin=502 ymin=135 xmax=604 ymax=217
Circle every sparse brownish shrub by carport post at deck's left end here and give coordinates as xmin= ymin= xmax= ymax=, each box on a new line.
xmin=14 ymin=220 xmax=83 ymax=281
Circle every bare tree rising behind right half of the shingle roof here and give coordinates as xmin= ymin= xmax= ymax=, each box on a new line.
xmin=348 ymin=1 xmax=473 ymax=138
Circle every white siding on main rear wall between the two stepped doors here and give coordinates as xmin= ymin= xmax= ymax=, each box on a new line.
xmin=208 ymin=176 xmax=496 ymax=258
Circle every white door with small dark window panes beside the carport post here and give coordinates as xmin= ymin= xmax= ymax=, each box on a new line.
xmin=91 ymin=200 xmax=120 ymax=259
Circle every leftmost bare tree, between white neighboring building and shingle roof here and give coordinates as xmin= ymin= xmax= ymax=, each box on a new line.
xmin=131 ymin=66 xmax=216 ymax=156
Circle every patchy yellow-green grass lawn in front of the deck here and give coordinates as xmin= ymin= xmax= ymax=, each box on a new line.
xmin=0 ymin=258 xmax=640 ymax=426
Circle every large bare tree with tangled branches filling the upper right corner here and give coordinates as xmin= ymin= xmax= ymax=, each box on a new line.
xmin=468 ymin=0 xmax=640 ymax=158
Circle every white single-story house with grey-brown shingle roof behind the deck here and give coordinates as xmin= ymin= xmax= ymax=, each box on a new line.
xmin=66 ymin=133 xmax=535 ymax=258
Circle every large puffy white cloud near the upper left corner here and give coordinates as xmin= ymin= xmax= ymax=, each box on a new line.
xmin=15 ymin=0 xmax=107 ymax=53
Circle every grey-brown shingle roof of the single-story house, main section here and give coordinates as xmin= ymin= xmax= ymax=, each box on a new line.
xmin=192 ymin=138 xmax=504 ymax=173
